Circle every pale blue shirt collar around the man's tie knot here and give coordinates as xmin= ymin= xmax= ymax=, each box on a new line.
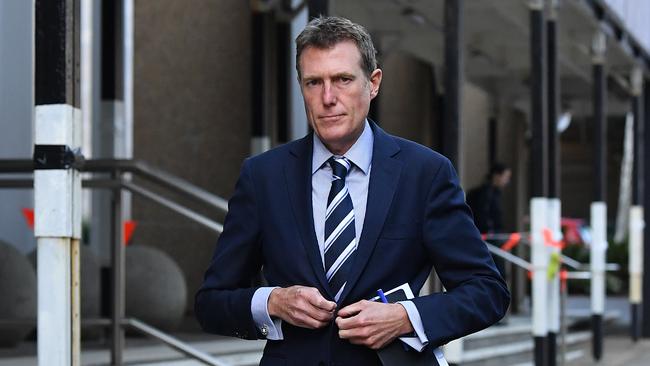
xmin=311 ymin=119 xmax=374 ymax=175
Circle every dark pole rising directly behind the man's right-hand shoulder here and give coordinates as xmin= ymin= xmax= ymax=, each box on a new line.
xmin=442 ymin=0 xmax=464 ymax=173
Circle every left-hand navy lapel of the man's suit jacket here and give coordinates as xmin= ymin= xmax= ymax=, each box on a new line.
xmin=284 ymin=134 xmax=334 ymax=298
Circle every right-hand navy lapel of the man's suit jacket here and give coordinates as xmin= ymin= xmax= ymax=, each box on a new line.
xmin=339 ymin=122 xmax=402 ymax=303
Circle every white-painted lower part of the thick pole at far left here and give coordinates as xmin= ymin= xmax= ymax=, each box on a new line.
xmin=34 ymin=104 xmax=81 ymax=366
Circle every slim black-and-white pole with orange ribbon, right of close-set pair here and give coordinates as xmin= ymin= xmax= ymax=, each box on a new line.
xmin=546 ymin=0 xmax=562 ymax=366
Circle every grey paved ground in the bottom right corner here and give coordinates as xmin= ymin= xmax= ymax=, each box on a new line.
xmin=567 ymin=335 xmax=650 ymax=366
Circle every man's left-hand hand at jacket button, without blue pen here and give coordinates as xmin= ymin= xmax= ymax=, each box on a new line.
xmin=268 ymin=286 xmax=336 ymax=329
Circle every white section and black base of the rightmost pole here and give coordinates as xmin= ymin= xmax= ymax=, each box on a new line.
xmin=628 ymin=206 xmax=645 ymax=341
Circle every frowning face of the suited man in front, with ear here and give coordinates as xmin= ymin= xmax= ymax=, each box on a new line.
xmin=300 ymin=41 xmax=382 ymax=155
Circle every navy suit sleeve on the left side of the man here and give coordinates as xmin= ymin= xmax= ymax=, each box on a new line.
xmin=194 ymin=160 xmax=262 ymax=339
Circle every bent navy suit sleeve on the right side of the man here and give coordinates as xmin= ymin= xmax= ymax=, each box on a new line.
xmin=413 ymin=159 xmax=510 ymax=347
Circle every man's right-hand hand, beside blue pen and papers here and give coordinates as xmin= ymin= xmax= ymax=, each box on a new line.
xmin=336 ymin=300 xmax=413 ymax=350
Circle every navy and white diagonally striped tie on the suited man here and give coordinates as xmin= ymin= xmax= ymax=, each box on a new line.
xmin=324 ymin=156 xmax=357 ymax=301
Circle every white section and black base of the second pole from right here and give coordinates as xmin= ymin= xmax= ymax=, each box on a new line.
xmin=590 ymin=202 xmax=607 ymax=358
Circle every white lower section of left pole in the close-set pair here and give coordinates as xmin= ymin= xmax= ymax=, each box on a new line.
xmin=530 ymin=197 xmax=548 ymax=354
